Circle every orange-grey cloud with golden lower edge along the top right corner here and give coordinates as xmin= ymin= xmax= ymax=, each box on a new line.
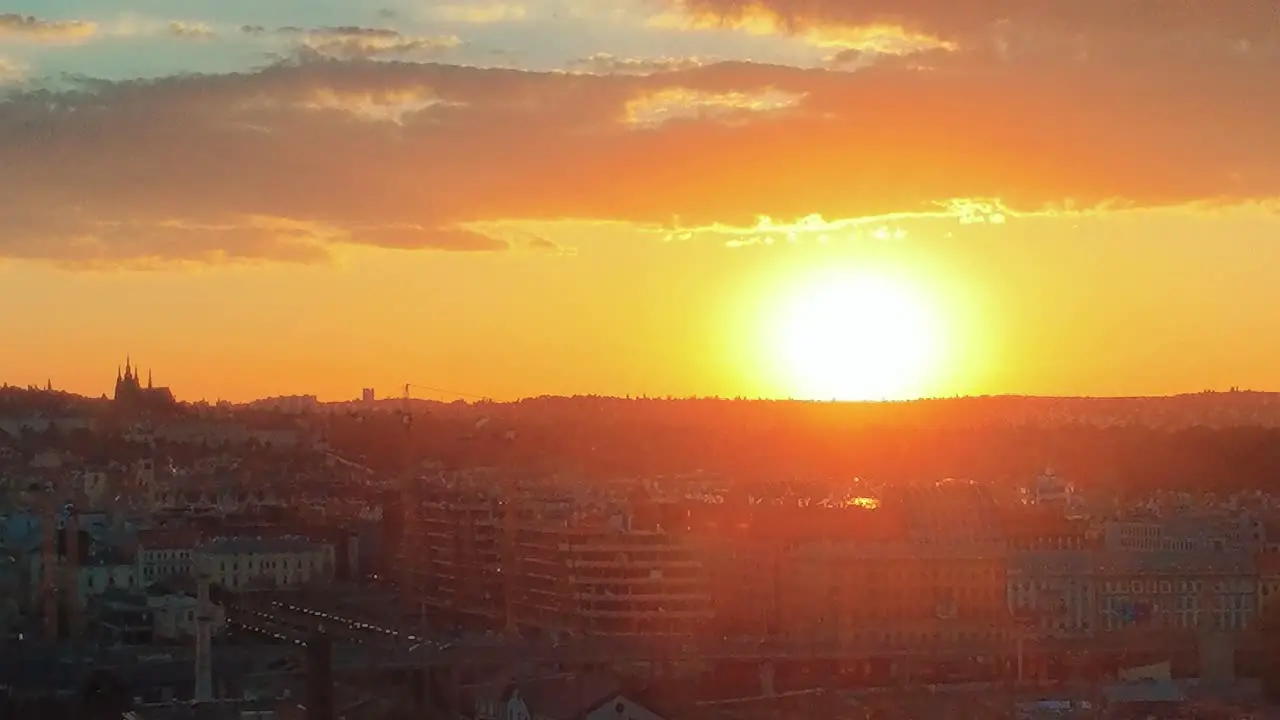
xmin=654 ymin=0 xmax=1280 ymax=61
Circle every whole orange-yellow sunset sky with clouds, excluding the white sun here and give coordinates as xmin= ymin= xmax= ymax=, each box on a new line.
xmin=0 ymin=0 xmax=1280 ymax=400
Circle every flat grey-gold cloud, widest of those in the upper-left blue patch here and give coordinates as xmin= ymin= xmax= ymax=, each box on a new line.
xmin=241 ymin=26 xmax=462 ymax=60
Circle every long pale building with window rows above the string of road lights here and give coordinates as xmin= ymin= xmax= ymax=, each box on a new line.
xmin=192 ymin=537 xmax=334 ymax=591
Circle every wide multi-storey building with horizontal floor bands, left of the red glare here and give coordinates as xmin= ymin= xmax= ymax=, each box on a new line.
xmin=401 ymin=480 xmax=712 ymax=635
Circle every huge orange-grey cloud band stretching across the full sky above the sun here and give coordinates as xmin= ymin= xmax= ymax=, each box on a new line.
xmin=0 ymin=39 xmax=1280 ymax=264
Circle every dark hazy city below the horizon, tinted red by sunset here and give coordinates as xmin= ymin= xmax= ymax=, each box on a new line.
xmin=0 ymin=371 xmax=1280 ymax=720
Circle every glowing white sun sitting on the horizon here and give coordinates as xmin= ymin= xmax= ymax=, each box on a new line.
xmin=772 ymin=270 xmax=943 ymax=401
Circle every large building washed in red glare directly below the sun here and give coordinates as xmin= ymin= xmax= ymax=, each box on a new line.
xmin=762 ymin=482 xmax=1011 ymax=655
